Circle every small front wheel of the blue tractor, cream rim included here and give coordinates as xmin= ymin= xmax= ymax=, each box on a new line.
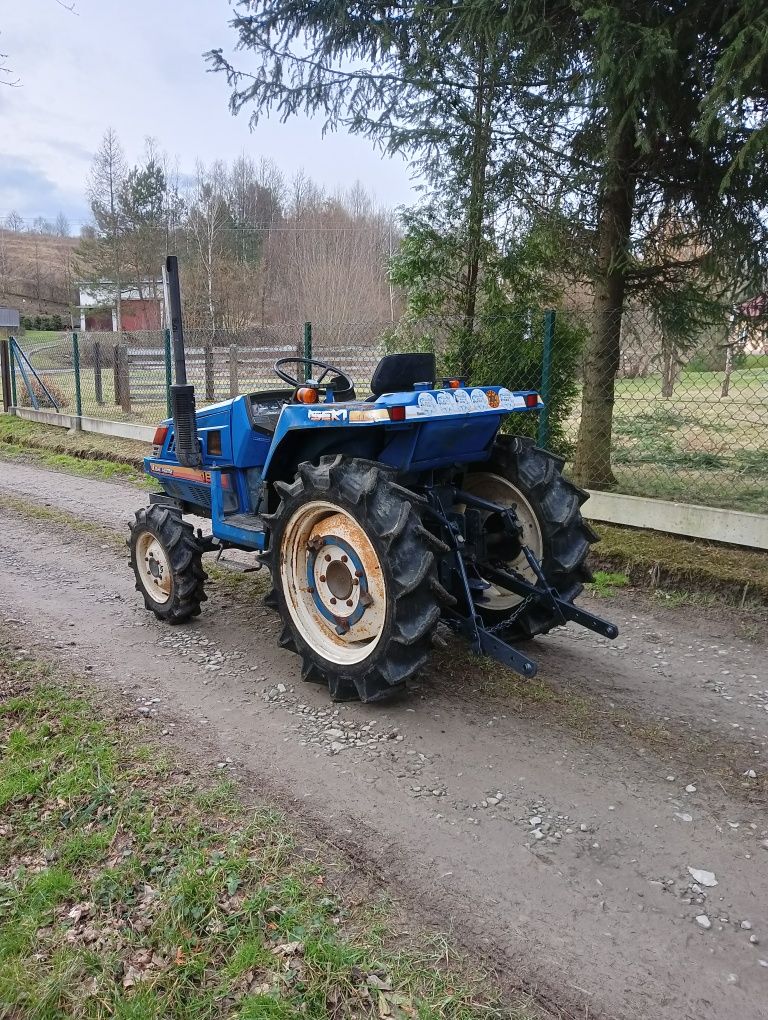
xmin=127 ymin=504 xmax=207 ymax=623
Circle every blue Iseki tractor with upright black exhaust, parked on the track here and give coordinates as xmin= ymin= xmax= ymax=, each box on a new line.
xmin=129 ymin=256 xmax=618 ymax=702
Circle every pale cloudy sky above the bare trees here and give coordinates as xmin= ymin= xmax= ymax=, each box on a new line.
xmin=0 ymin=0 xmax=414 ymax=227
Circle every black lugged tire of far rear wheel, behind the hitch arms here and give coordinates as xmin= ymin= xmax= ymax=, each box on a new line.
xmin=477 ymin=436 xmax=598 ymax=641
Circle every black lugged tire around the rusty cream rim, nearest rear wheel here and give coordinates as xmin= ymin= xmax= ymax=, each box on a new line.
xmin=265 ymin=456 xmax=446 ymax=702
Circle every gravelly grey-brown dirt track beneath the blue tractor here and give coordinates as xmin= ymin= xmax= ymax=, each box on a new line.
xmin=0 ymin=463 xmax=768 ymax=1020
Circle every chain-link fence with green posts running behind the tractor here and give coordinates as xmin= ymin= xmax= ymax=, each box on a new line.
xmin=4 ymin=301 xmax=768 ymax=513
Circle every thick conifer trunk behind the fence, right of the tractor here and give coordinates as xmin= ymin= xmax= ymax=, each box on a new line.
xmin=573 ymin=121 xmax=635 ymax=489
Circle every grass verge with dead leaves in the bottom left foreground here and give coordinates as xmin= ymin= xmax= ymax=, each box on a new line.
xmin=0 ymin=640 xmax=533 ymax=1020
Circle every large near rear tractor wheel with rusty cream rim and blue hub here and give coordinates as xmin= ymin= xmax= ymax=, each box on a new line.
xmin=265 ymin=456 xmax=451 ymax=702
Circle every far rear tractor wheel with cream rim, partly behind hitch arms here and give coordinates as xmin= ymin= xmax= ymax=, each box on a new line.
xmin=464 ymin=436 xmax=598 ymax=641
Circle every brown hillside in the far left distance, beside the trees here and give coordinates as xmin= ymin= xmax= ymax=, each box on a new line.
xmin=0 ymin=228 xmax=78 ymax=315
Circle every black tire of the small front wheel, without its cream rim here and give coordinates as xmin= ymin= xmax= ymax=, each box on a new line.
xmin=127 ymin=504 xmax=208 ymax=623
